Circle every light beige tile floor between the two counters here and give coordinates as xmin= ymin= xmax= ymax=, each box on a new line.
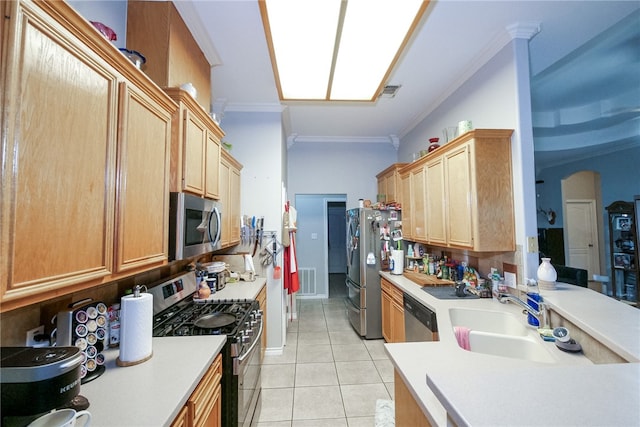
xmin=258 ymin=281 xmax=393 ymax=427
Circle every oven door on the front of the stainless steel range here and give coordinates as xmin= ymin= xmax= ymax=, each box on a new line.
xmin=234 ymin=321 xmax=264 ymax=427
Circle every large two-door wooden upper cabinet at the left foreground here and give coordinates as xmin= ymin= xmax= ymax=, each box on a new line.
xmin=0 ymin=0 xmax=176 ymax=311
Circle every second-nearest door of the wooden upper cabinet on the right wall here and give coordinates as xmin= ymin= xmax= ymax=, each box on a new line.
xmin=425 ymin=157 xmax=447 ymax=245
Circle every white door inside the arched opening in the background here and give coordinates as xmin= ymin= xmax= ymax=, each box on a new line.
xmin=565 ymin=200 xmax=600 ymax=277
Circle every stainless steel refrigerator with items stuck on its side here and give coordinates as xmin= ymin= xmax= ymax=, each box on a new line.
xmin=346 ymin=208 xmax=401 ymax=339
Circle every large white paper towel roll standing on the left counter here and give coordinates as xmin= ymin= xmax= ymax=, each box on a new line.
xmin=116 ymin=293 xmax=153 ymax=366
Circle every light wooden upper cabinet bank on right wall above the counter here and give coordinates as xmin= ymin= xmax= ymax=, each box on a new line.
xmin=400 ymin=129 xmax=515 ymax=252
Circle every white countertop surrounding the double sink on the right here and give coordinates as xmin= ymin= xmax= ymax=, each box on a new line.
xmin=381 ymin=273 xmax=640 ymax=425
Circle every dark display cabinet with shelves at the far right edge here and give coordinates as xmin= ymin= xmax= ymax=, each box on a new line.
xmin=607 ymin=201 xmax=638 ymax=305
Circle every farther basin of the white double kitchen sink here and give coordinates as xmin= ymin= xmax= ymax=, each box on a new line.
xmin=449 ymin=308 xmax=529 ymax=337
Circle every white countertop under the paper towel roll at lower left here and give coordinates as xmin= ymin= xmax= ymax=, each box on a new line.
xmin=80 ymin=335 xmax=226 ymax=427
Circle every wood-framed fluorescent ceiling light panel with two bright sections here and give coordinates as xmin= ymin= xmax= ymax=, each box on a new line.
xmin=259 ymin=0 xmax=428 ymax=101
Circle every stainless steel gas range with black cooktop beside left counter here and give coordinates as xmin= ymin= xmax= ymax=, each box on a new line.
xmin=149 ymin=272 xmax=263 ymax=426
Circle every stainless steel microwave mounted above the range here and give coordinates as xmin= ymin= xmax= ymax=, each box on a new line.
xmin=169 ymin=193 xmax=222 ymax=261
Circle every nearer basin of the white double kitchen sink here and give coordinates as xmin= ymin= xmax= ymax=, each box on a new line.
xmin=469 ymin=330 xmax=557 ymax=363
